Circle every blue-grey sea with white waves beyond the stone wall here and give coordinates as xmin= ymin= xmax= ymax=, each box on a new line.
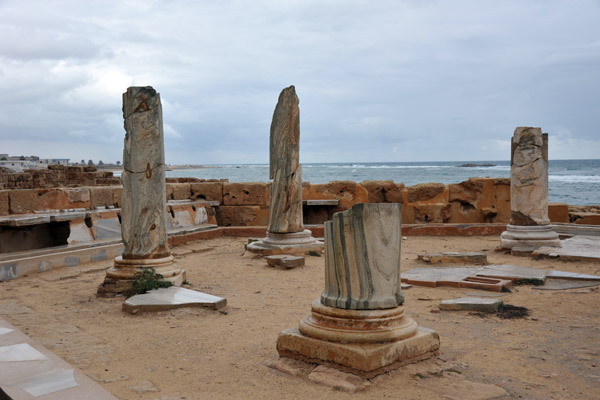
xmin=167 ymin=159 xmax=600 ymax=205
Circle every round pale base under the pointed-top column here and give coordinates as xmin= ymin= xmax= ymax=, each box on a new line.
xmin=247 ymin=229 xmax=324 ymax=256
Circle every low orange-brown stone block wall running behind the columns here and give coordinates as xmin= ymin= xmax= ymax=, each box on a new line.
xmin=0 ymin=177 xmax=600 ymax=226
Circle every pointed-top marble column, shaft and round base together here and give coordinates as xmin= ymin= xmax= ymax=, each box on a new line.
xmin=247 ymin=86 xmax=323 ymax=255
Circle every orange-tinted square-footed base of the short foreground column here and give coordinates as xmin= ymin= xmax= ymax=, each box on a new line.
xmin=277 ymin=300 xmax=440 ymax=378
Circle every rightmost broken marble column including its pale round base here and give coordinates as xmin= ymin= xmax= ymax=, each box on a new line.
xmin=501 ymin=127 xmax=560 ymax=250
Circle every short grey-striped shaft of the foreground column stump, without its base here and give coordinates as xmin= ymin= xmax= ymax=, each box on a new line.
xmin=321 ymin=203 xmax=404 ymax=310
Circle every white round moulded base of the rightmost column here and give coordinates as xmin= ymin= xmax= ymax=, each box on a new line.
xmin=500 ymin=224 xmax=561 ymax=250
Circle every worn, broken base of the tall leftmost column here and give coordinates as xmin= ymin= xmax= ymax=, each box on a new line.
xmin=96 ymin=256 xmax=185 ymax=297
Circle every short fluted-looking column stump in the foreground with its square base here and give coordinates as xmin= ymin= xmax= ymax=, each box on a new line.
xmin=277 ymin=203 xmax=439 ymax=377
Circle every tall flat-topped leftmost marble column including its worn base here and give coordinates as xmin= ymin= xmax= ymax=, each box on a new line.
xmin=98 ymin=86 xmax=185 ymax=296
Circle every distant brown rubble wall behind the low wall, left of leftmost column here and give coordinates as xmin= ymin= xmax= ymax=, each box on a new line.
xmin=0 ymin=165 xmax=121 ymax=189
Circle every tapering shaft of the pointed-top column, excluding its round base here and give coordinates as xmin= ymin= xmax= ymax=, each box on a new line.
xmin=267 ymin=86 xmax=304 ymax=233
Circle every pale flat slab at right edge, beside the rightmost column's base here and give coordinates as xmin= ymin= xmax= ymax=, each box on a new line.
xmin=532 ymin=235 xmax=600 ymax=263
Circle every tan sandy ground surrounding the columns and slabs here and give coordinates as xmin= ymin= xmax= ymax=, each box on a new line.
xmin=0 ymin=237 xmax=600 ymax=400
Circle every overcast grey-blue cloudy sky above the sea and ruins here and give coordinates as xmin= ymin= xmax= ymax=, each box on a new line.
xmin=0 ymin=0 xmax=600 ymax=164
